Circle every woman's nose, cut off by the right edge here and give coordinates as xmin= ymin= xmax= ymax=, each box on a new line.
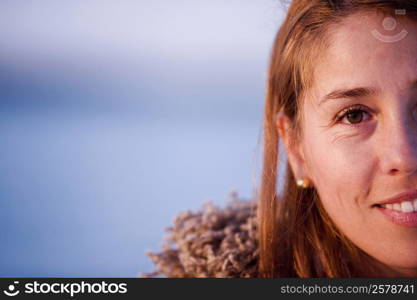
xmin=380 ymin=114 xmax=417 ymax=175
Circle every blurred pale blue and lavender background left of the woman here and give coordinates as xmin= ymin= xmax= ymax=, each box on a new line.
xmin=0 ymin=0 xmax=283 ymax=277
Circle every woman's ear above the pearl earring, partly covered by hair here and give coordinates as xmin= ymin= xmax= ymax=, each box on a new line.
xmin=276 ymin=113 xmax=308 ymax=180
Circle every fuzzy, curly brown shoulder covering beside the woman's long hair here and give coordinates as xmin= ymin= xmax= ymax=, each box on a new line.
xmin=145 ymin=193 xmax=258 ymax=278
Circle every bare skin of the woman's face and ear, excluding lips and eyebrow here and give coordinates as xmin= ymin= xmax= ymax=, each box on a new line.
xmin=277 ymin=12 xmax=417 ymax=277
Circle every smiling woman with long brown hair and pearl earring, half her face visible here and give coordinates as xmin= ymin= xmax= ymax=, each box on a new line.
xmin=145 ymin=0 xmax=417 ymax=277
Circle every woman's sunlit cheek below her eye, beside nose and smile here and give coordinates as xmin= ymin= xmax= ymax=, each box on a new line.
xmin=300 ymin=134 xmax=375 ymax=218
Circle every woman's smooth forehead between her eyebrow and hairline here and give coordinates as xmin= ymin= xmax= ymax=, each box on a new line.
xmin=312 ymin=12 xmax=417 ymax=97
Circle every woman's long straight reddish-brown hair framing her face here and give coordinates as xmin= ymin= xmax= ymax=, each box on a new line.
xmin=258 ymin=0 xmax=417 ymax=277
